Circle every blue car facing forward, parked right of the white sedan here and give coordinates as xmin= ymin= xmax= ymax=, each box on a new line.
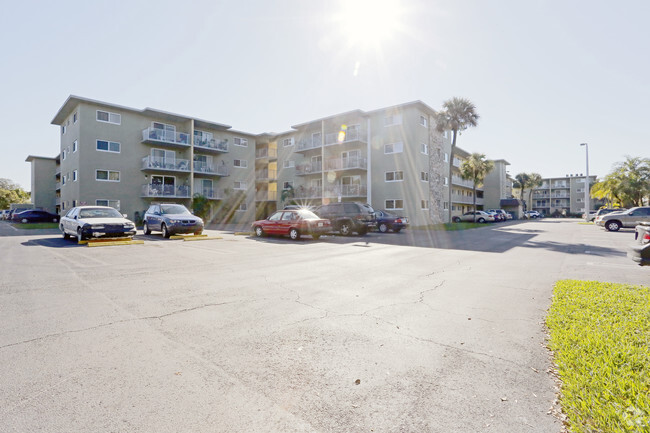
xmin=142 ymin=203 xmax=203 ymax=238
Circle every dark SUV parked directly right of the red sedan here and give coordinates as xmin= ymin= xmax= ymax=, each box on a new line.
xmin=315 ymin=202 xmax=376 ymax=236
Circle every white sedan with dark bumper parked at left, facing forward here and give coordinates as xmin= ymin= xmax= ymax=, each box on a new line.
xmin=59 ymin=206 xmax=135 ymax=241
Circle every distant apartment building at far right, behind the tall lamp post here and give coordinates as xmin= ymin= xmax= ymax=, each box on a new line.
xmin=524 ymin=174 xmax=603 ymax=215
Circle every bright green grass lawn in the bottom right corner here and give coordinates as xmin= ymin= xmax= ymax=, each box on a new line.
xmin=546 ymin=280 xmax=650 ymax=433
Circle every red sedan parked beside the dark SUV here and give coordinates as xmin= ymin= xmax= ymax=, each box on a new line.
xmin=253 ymin=209 xmax=332 ymax=240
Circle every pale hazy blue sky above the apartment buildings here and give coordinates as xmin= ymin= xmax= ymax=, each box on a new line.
xmin=0 ymin=0 xmax=650 ymax=190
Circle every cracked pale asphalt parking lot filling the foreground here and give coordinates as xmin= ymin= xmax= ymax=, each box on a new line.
xmin=0 ymin=219 xmax=650 ymax=433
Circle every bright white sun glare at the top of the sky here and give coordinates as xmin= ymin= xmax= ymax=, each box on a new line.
xmin=336 ymin=0 xmax=403 ymax=48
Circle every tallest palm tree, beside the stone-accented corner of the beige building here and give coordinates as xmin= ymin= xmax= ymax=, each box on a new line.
xmin=434 ymin=97 xmax=479 ymax=221
